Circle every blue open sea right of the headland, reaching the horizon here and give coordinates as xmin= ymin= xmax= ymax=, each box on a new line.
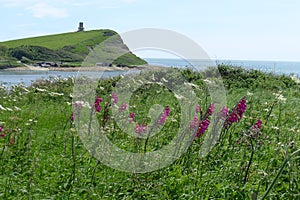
xmin=145 ymin=58 xmax=300 ymax=76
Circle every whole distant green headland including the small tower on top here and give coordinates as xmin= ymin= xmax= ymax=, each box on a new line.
xmin=0 ymin=22 xmax=147 ymax=69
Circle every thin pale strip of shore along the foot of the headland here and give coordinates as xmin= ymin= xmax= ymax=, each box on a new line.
xmin=2 ymin=65 xmax=165 ymax=72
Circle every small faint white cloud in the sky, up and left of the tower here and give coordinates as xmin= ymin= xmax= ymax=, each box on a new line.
xmin=27 ymin=3 xmax=68 ymax=18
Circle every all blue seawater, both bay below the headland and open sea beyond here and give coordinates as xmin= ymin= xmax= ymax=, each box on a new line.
xmin=0 ymin=58 xmax=300 ymax=88
